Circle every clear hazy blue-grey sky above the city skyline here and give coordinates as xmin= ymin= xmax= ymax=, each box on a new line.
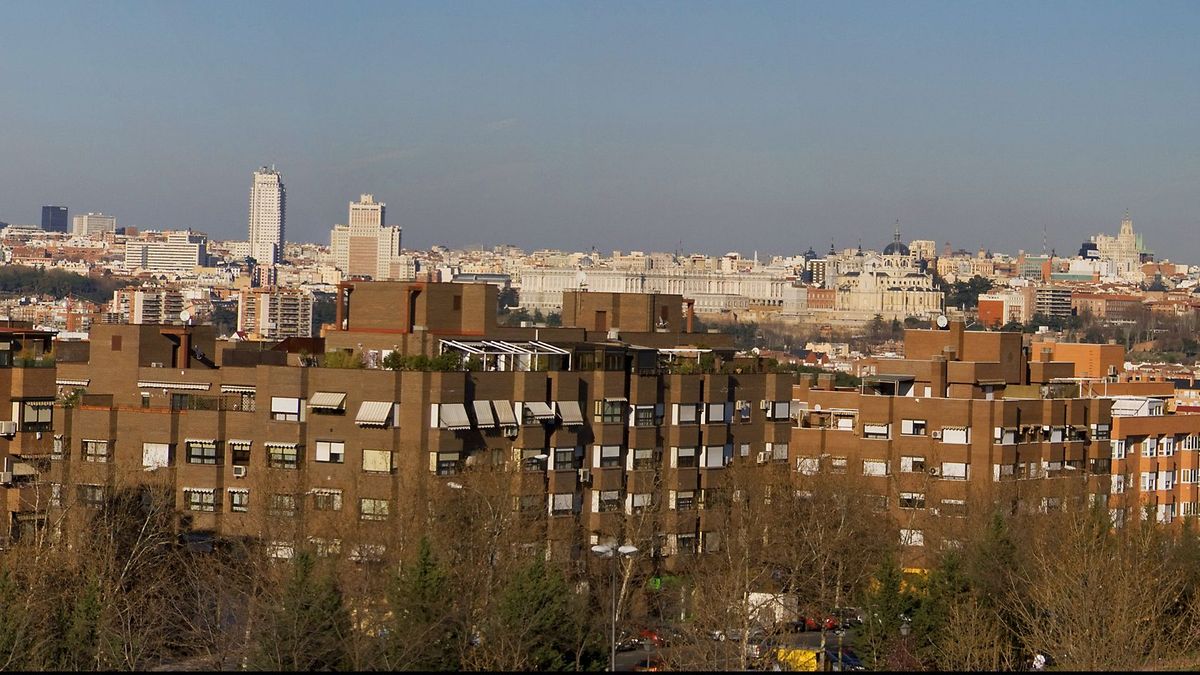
xmin=0 ymin=0 xmax=1200 ymax=263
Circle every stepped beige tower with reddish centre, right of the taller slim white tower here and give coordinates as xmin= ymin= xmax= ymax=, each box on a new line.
xmin=329 ymin=195 xmax=401 ymax=281
